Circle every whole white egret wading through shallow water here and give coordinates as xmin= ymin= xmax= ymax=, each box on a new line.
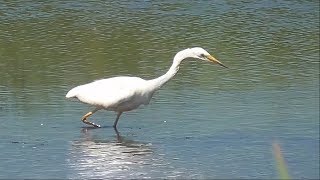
xmin=66 ymin=47 xmax=226 ymax=128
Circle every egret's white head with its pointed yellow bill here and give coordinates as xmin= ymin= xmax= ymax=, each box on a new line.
xmin=188 ymin=47 xmax=228 ymax=68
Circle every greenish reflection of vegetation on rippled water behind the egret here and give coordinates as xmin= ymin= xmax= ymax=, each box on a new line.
xmin=0 ymin=1 xmax=319 ymax=114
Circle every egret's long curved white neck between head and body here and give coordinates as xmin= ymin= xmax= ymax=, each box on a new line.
xmin=149 ymin=49 xmax=189 ymax=90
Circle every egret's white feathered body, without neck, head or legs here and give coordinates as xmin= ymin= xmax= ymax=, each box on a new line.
xmin=66 ymin=76 xmax=151 ymax=112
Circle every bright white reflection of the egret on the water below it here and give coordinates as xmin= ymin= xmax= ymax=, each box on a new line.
xmin=68 ymin=128 xmax=153 ymax=179
